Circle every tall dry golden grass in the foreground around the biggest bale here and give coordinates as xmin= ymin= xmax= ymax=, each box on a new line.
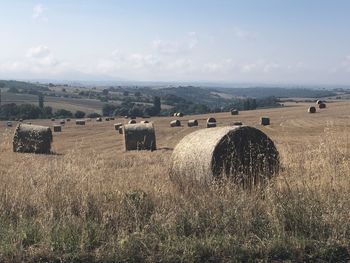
xmin=0 ymin=129 xmax=350 ymax=262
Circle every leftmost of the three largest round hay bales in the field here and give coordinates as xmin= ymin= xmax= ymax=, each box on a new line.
xmin=13 ymin=124 xmax=52 ymax=153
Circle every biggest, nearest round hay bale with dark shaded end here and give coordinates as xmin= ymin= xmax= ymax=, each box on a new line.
xmin=170 ymin=126 xmax=279 ymax=187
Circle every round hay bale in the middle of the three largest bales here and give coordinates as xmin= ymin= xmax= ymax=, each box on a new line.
xmin=123 ymin=123 xmax=156 ymax=151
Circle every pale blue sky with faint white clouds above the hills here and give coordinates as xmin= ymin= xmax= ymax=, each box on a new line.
xmin=0 ymin=0 xmax=350 ymax=84
